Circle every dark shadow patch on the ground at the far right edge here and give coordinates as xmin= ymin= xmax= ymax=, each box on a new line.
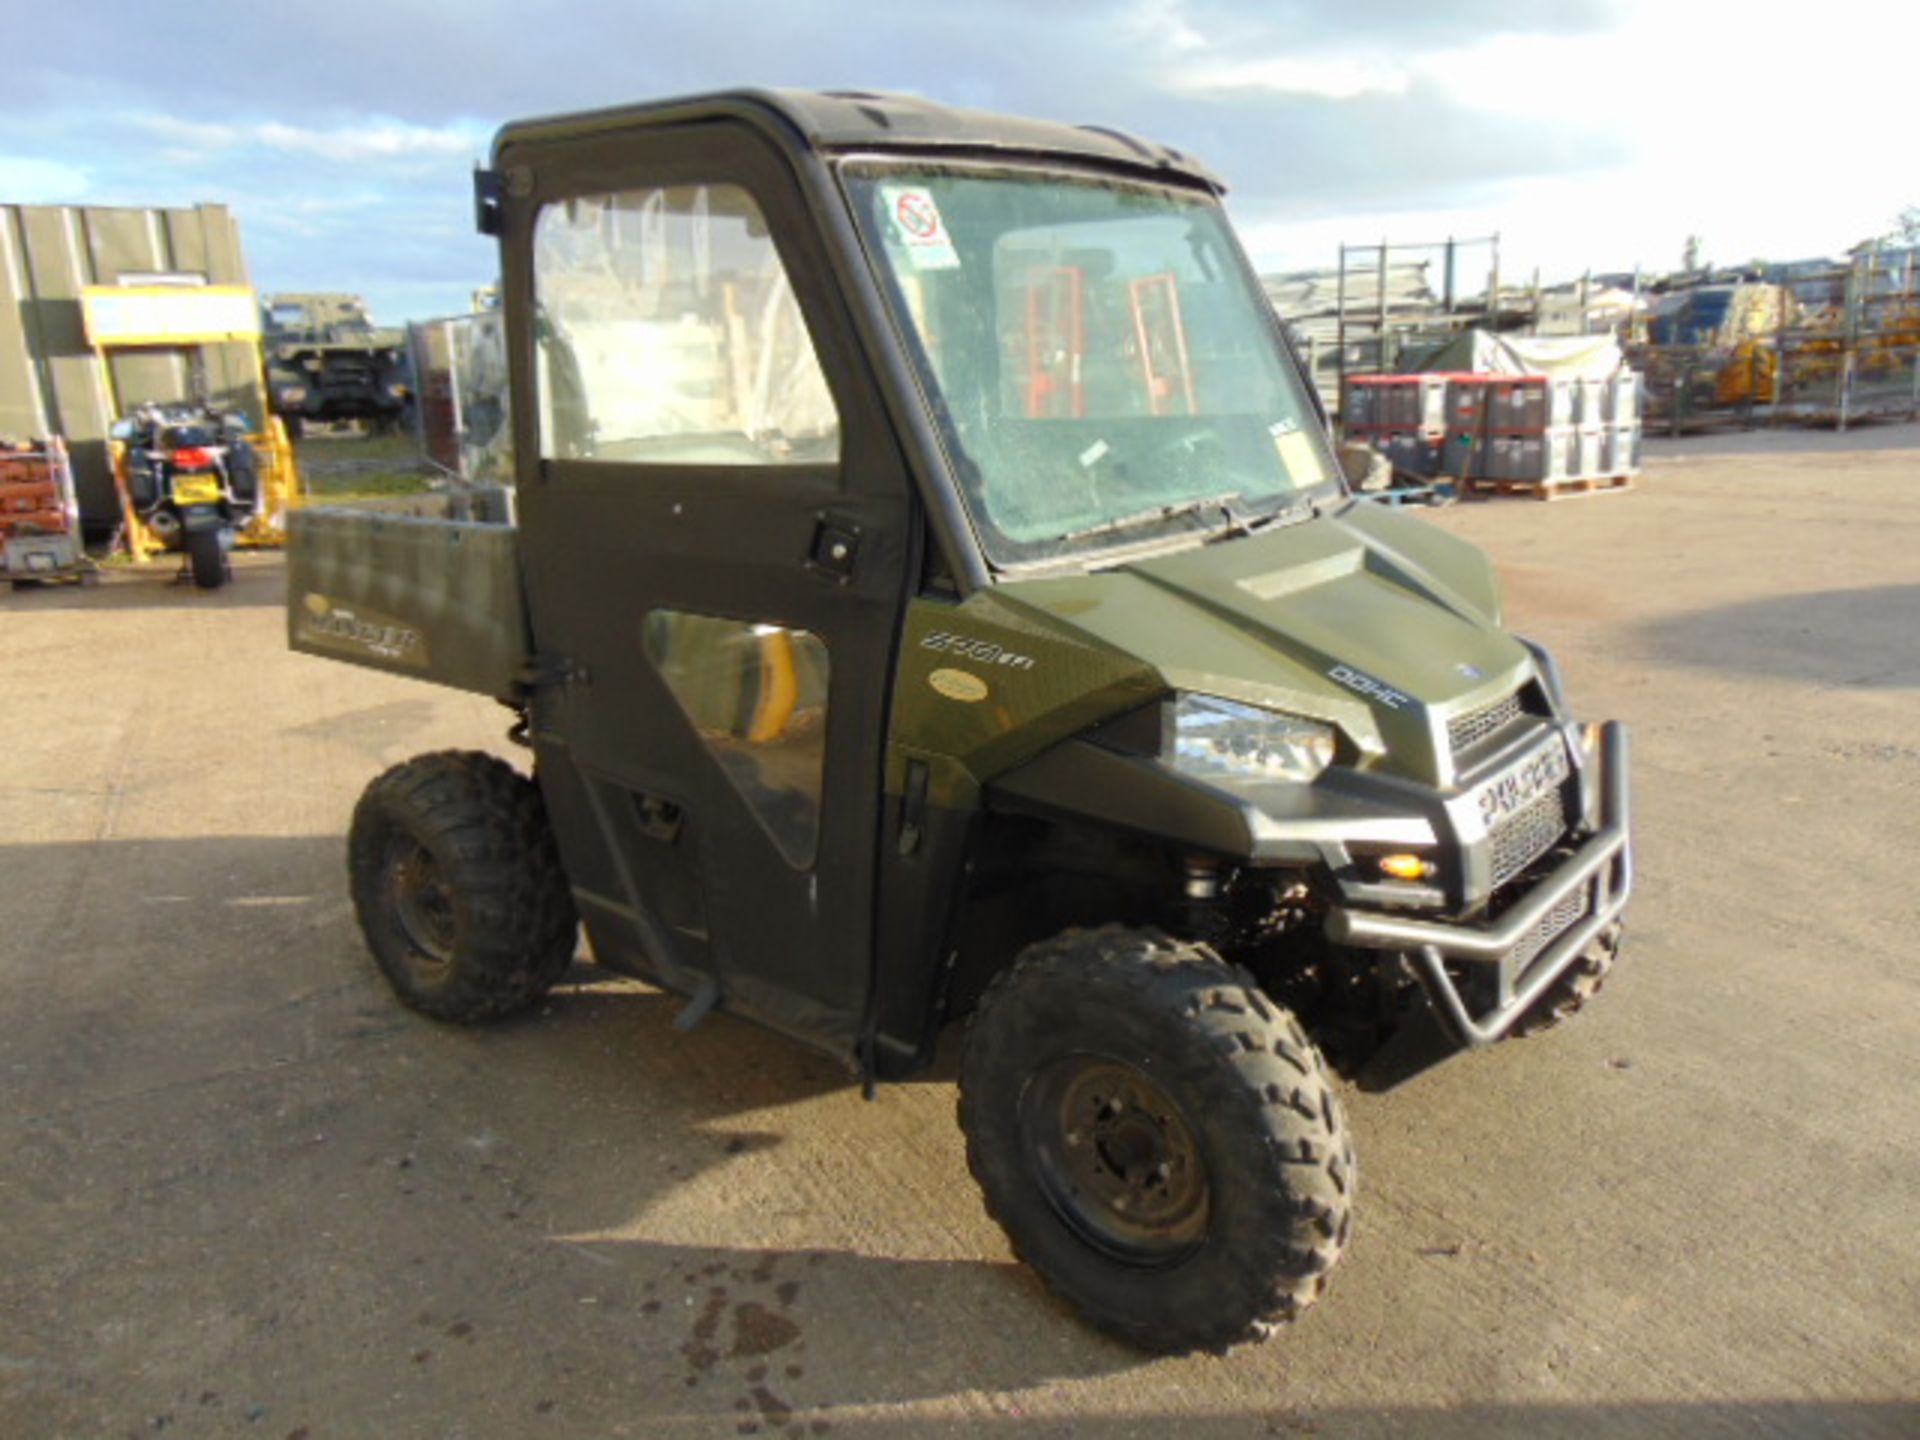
xmin=1638 ymin=586 xmax=1920 ymax=689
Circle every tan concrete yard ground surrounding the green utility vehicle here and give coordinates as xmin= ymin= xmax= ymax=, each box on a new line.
xmin=0 ymin=428 xmax=1920 ymax=1440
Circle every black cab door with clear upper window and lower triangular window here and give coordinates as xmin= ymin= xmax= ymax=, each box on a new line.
xmin=501 ymin=121 xmax=912 ymax=1056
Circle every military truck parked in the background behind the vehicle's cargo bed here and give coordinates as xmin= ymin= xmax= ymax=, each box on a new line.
xmin=261 ymin=294 xmax=409 ymax=440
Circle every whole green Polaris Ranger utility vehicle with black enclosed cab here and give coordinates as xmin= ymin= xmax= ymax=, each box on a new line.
xmin=288 ymin=94 xmax=1628 ymax=1350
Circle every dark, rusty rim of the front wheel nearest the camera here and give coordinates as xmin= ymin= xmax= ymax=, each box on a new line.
xmin=1020 ymin=1054 xmax=1212 ymax=1269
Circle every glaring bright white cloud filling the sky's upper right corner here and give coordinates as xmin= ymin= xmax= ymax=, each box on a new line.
xmin=1160 ymin=0 xmax=1920 ymax=280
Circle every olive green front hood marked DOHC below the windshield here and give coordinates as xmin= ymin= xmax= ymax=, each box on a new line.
xmin=998 ymin=501 xmax=1532 ymax=785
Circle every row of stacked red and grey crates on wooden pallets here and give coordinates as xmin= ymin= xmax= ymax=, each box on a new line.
xmin=1342 ymin=371 xmax=1642 ymax=499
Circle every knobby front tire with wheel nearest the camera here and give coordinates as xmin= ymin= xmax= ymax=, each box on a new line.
xmin=960 ymin=925 xmax=1356 ymax=1354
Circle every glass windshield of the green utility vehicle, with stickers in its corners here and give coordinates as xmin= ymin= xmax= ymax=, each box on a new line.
xmin=843 ymin=161 xmax=1332 ymax=564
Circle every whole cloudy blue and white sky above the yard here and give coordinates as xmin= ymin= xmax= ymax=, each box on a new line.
xmin=0 ymin=0 xmax=1920 ymax=321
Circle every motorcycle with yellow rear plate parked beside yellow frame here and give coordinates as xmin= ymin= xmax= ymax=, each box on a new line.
xmin=111 ymin=405 xmax=259 ymax=589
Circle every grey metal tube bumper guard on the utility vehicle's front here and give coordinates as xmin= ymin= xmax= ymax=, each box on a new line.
xmin=1327 ymin=722 xmax=1634 ymax=1046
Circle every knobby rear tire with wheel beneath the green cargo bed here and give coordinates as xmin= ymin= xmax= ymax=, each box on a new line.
xmin=348 ymin=751 xmax=578 ymax=1023
